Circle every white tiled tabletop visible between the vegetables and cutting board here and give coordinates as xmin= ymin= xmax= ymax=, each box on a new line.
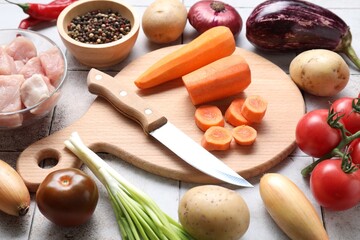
xmin=0 ymin=0 xmax=360 ymax=240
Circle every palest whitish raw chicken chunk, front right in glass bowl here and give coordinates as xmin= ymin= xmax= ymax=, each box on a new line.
xmin=20 ymin=74 xmax=50 ymax=107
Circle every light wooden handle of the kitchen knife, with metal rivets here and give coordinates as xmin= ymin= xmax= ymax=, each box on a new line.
xmin=87 ymin=68 xmax=167 ymax=134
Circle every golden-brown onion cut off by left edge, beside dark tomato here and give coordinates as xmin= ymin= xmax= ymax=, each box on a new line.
xmin=0 ymin=160 xmax=30 ymax=216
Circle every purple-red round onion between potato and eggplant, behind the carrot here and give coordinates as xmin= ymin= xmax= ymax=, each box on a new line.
xmin=188 ymin=1 xmax=242 ymax=37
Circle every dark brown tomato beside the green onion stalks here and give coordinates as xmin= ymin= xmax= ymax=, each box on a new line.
xmin=36 ymin=168 xmax=99 ymax=227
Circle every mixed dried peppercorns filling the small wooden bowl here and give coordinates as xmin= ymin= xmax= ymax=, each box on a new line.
xmin=67 ymin=9 xmax=131 ymax=44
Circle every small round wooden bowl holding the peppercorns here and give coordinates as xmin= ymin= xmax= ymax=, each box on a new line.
xmin=57 ymin=0 xmax=140 ymax=67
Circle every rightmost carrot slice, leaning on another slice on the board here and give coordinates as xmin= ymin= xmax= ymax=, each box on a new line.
xmin=241 ymin=95 xmax=267 ymax=123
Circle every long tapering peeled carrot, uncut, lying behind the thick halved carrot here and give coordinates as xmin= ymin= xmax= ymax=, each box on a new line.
xmin=135 ymin=26 xmax=236 ymax=89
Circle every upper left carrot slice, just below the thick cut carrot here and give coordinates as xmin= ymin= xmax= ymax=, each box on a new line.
xmin=195 ymin=105 xmax=225 ymax=132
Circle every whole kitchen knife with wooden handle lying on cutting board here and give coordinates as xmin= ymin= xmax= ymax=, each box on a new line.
xmin=87 ymin=68 xmax=253 ymax=187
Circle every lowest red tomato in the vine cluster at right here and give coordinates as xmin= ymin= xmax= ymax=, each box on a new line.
xmin=310 ymin=159 xmax=360 ymax=211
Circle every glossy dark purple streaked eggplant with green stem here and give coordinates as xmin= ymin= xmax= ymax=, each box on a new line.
xmin=246 ymin=0 xmax=360 ymax=69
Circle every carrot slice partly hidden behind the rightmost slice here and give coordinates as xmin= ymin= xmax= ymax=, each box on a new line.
xmin=225 ymin=98 xmax=251 ymax=127
